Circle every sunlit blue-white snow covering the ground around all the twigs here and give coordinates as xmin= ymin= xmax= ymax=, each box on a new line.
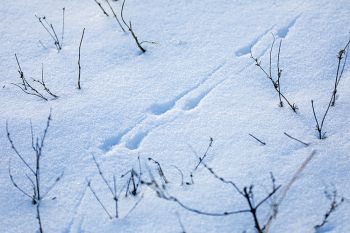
xmin=0 ymin=0 xmax=350 ymax=233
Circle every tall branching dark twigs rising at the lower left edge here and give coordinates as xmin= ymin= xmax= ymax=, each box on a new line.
xmin=6 ymin=111 xmax=63 ymax=233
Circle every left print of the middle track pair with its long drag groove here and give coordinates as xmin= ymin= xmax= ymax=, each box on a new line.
xmin=149 ymin=62 xmax=225 ymax=115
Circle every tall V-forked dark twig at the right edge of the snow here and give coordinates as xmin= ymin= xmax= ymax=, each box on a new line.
xmin=311 ymin=36 xmax=350 ymax=139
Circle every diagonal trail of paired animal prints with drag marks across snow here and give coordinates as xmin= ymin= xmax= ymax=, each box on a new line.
xmin=104 ymin=18 xmax=292 ymax=153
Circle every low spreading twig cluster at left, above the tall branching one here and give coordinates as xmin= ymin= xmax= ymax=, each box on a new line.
xmin=11 ymin=54 xmax=58 ymax=101
